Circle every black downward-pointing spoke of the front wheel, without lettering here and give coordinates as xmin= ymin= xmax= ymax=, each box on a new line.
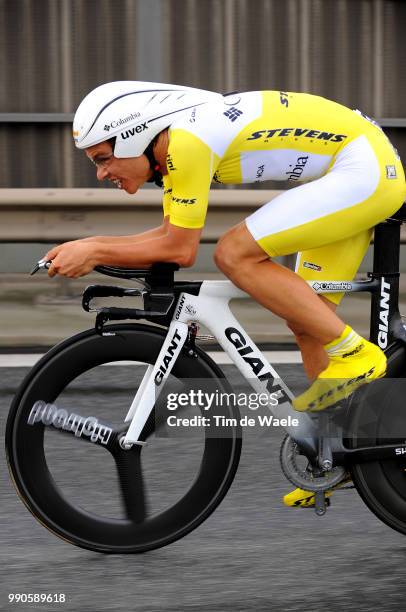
xmin=114 ymin=447 xmax=147 ymax=523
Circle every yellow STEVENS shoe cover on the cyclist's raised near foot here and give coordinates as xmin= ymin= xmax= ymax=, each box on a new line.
xmin=292 ymin=338 xmax=386 ymax=412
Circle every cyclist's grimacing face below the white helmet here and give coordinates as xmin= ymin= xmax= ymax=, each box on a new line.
xmin=85 ymin=142 xmax=152 ymax=193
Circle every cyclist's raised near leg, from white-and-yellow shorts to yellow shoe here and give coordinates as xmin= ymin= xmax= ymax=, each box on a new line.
xmin=216 ymin=136 xmax=406 ymax=410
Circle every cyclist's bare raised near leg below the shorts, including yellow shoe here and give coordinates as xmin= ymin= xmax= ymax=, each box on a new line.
xmin=216 ymin=218 xmax=386 ymax=410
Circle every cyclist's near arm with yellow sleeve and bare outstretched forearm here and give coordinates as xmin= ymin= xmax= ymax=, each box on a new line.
xmin=46 ymin=130 xmax=219 ymax=277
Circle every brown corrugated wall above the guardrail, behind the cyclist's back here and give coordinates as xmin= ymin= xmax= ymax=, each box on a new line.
xmin=0 ymin=0 xmax=406 ymax=188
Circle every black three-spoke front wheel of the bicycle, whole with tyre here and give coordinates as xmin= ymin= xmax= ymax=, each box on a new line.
xmin=6 ymin=324 xmax=241 ymax=553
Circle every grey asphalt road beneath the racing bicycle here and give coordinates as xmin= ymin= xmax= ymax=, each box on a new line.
xmin=0 ymin=365 xmax=406 ymax=612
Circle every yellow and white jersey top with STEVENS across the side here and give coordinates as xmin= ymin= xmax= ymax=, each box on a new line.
xmin=163 ymin=91 xmax=388 ymax=228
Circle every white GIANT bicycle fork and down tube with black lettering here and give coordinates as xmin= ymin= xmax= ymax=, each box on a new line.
xmin=123 ymin=281 xmax=356 ymax=452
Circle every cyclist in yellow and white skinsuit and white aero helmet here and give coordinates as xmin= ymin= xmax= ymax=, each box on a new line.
xmin=46 ymin=81 xmax=406 ymax=505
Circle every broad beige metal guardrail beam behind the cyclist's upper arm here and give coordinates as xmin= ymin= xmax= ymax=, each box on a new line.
xmin=0 ymin=188 xmax=406 ymax=244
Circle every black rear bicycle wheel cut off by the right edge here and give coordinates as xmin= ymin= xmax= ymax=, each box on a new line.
xmin=347 ymin=343 xmax=406 ymax=534
